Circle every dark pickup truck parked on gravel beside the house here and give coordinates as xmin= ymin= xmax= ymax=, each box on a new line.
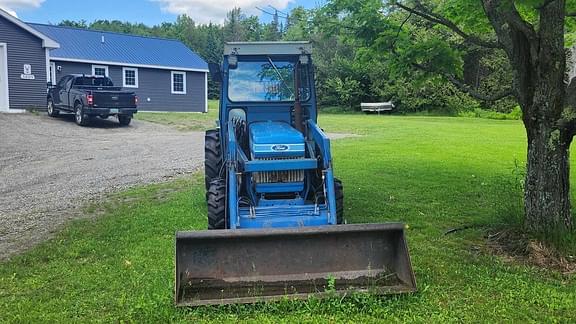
xmin=47 ymin=74 xmax=138 ymax=126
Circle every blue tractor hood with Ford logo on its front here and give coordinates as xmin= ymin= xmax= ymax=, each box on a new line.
xmin=250 ymin=121 xmax=305 ymax=159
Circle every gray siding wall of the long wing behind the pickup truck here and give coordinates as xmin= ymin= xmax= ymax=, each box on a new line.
xmin=53 ymin=61 xmax=206 ymax=112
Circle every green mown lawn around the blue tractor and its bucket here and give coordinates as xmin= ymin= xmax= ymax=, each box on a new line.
xmin=0 ymin=110 xmax=576 ymax=323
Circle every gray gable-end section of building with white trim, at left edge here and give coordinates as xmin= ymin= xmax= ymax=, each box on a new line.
xmin=0 ymin=9 xmax=59 ymax=112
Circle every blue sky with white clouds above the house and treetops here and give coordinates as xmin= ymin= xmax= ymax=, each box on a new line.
xmin=0 ymin=0 xmax=324 ymax=25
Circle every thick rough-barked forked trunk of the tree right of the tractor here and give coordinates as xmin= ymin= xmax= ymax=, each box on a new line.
xmin=483 ymin=0 xmax=576 ymax=238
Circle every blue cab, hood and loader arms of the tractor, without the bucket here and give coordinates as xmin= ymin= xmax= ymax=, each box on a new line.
xmin=207 ymin=42 xmax=343 ymax=228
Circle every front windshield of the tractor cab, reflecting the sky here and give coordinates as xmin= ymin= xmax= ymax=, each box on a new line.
xmin=228 ymin=57 xmax=310 ymax=101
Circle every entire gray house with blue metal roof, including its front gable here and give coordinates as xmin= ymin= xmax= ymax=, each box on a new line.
xmin=0 ymin=10 xmax=208 ymax=112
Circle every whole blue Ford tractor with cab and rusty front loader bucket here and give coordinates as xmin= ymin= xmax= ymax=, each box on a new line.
xmin=175 ymin=42 xmax=415 ymax=305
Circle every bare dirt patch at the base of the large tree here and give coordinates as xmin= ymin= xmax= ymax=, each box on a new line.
xmin=487 ymin=230 xmax=576 ymax=275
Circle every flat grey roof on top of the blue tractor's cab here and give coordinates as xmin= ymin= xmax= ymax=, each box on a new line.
xmin=224 ymin=41 xmax=312 ymax=55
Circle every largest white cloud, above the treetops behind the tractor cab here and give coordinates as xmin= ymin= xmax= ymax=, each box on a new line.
xmin=153 ymin=0 xmax=294 ymax=23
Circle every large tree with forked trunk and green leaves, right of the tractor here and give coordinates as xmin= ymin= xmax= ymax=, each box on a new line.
xmin=332 ymin=0 xmax=576 ymax=236
